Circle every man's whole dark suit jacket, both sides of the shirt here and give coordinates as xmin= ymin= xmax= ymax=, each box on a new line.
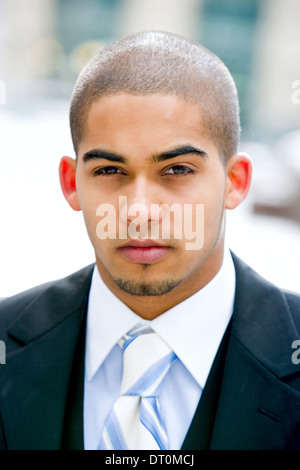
xmin=0 ymin=256 xmax=300 ymax=450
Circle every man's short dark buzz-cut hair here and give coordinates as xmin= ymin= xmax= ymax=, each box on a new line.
xmin=70 ymin=31 xmax=240 ymax=162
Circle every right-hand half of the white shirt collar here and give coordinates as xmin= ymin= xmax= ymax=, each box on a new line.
xmin=152 ymin=250 xmax=235 ymax=388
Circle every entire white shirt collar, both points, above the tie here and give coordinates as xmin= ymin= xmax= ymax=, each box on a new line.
xmin=85 ymin=250 xmax=235 ymax=388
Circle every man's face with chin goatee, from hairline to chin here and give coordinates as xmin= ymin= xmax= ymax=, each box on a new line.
xmin=76 ymin=93 xmax=227 ymax=308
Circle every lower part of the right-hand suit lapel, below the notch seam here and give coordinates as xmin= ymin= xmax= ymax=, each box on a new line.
xmin=210 ymin=338 xmax=300 ymax=450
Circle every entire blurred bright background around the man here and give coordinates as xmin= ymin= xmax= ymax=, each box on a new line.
xmin=0 ymin=0 xmax=300 ymax=297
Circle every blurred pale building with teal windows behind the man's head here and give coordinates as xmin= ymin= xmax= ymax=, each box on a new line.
xmin=0 ymin=0 xmax=300 ymax=137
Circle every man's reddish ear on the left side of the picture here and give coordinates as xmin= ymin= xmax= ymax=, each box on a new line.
xmin=59 ymin=157 xmax=81 ymax=211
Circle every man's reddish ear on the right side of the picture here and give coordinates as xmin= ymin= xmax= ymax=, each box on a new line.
xmin=225 ymin=153 xmax=252 ymax=209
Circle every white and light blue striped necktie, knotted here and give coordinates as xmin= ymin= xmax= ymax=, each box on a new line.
xmin=99 ymin=325 xmax=176 ymax=450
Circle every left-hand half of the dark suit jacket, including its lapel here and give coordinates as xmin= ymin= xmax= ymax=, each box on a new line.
xmin=1 ymin=266 xmax=92 ymax=450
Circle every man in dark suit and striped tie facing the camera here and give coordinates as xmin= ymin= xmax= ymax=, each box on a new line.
xmin=0 ymin=32 xmax=300 ymax=450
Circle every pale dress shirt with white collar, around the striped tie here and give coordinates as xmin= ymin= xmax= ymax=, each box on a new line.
xmin=84 ymin=249 xmax=235 ymax=450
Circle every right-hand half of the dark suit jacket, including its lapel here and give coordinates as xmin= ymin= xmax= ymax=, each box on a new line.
xmin=183 ymin=256 xmax=300 ymax=450
